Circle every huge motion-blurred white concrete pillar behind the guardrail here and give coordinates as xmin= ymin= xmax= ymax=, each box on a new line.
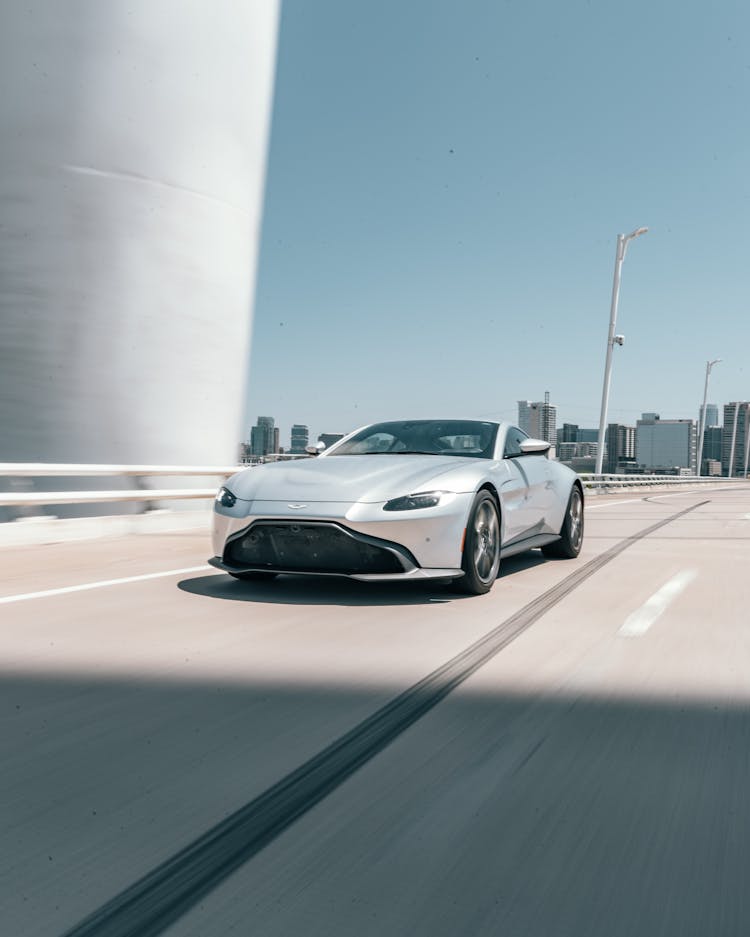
xmin=0 ymin=0 xmax=278 ymax=464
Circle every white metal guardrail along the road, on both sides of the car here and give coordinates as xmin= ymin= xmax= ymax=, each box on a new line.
xmin=0 ymin=462 xmax=746 ymax=507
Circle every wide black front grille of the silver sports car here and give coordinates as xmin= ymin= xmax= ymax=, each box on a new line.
xmin=224 ymin=521 xmax=412 ymax=575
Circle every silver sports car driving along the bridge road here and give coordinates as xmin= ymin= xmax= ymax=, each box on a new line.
xmin=209 ymin=420 xmax=583 ymax=595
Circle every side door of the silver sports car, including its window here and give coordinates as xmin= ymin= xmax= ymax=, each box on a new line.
xmin=500 ymin=426 xmax=551 ymax=543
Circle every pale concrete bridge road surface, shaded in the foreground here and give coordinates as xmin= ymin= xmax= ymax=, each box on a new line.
xmin=0 ymin=488 xmax=750 ymax=937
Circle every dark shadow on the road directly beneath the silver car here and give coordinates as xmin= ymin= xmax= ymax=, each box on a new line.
xmin=177 ymin=550 xmax=546 ymax=607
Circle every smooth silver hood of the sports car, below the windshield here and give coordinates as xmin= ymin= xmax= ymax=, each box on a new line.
xmin=227 ymin=455 xmax=480 ymax=503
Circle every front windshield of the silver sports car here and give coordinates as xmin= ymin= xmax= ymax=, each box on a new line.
xmin=330 ymin=420 xmax=497 ymax=459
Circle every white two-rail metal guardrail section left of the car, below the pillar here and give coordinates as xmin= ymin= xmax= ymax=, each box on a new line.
xmin=0 ymin=462 xmax=243 ymax=507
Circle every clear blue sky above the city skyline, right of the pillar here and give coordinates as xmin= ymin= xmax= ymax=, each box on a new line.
xmin=246 ymin=0 xmax=750 ymax=445
